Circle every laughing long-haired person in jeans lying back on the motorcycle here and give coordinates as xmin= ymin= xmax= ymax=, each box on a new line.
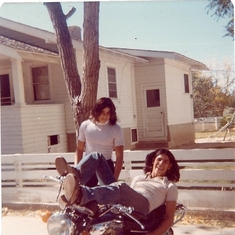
xmin=55 ymin=149 xmax=180 ymax=235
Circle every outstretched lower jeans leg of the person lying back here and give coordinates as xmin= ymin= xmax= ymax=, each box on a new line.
xmin=79 ymin=182 xmax=149 ymax=215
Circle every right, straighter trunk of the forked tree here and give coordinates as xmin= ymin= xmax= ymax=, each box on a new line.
xmin=79 ymin=2 xmax=100 ymax=125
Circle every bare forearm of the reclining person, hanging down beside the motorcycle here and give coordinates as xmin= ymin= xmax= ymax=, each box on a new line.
xmin=147 ymin=201 xmax=176 ymax=235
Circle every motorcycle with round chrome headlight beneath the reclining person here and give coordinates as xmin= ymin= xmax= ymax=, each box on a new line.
xmin=46 ymin=177 xmax=186 ymax=235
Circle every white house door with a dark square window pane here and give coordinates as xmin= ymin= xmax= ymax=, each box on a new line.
xmin=143 ymin=86 xmax=164 ymax=138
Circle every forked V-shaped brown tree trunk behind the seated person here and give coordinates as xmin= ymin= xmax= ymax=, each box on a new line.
xmin=44 ymin=2 xmax=100 ymax=138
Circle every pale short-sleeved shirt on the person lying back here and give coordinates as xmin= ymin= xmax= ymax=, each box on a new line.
xmin=131 ymin=175 xmax=178 ymax=212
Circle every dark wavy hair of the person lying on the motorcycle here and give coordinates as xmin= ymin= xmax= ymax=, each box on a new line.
xmin=144 ymin=149 xmax=180 ymax=182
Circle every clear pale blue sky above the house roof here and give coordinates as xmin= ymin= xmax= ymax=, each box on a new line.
xmin=0 ymin=0 xmax=234 ymax=74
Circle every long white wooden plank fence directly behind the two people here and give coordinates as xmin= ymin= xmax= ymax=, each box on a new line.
xmin=1 ymin=149 xmax=235 ymax=210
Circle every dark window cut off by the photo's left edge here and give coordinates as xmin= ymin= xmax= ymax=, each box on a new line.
xmin=0 ymin=74 xmax=11 ymax=106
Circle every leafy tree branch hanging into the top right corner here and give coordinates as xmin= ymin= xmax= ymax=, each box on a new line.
xmin=207 ymin=0 xmax=234 ymax=39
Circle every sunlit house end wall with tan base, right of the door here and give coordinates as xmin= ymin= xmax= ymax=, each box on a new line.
xmin=165 ymin=59 xmax=195 ymax=147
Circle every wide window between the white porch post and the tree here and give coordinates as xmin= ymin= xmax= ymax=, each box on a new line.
xmin=32 ymin=66 xmax=50 ymax=100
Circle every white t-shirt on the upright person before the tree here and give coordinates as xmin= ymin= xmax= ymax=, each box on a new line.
xmin=78 ymin=119 xmax=124 ymax=160
